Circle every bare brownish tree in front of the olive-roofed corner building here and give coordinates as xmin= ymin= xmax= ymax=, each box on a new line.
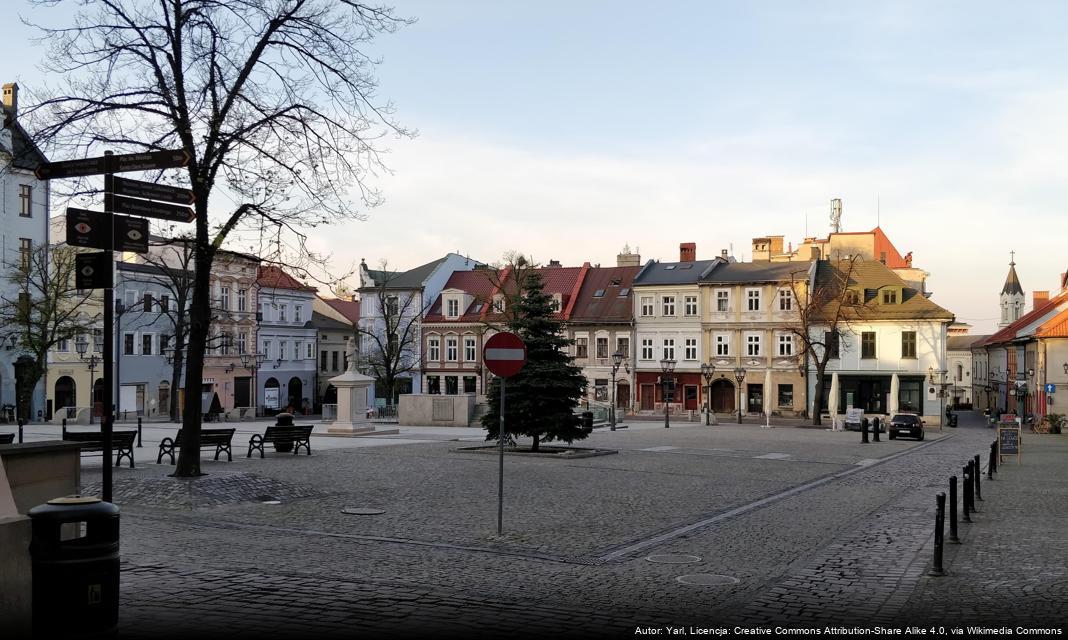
xmin=789 ymin=255 xmax=864 ymax=424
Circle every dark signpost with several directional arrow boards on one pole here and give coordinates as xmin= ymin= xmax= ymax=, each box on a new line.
xmin=33 ymin=149 xmax=194 ymax=502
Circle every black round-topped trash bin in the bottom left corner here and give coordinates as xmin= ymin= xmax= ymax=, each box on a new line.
xmin=29 ymin=496 xmax=119 ymax=638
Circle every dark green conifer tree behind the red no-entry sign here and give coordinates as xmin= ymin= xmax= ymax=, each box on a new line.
xmin=482 ymin=269 xmax=588 ymax=451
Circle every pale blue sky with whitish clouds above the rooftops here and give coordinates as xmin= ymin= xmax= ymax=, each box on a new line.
xmin=0 ymin=0 xmax=1068 ymax=333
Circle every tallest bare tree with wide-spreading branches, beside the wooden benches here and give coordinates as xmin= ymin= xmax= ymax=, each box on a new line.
xmin=27 ymin=0 xmax=409 ymax=477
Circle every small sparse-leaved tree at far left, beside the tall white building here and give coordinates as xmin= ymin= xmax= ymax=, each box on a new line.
xmin=0 ymin=245 xmax=99 ymax=420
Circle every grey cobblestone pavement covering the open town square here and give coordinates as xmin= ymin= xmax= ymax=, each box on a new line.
xmin=62 ymin=413 xmax=1066 ymax=637
